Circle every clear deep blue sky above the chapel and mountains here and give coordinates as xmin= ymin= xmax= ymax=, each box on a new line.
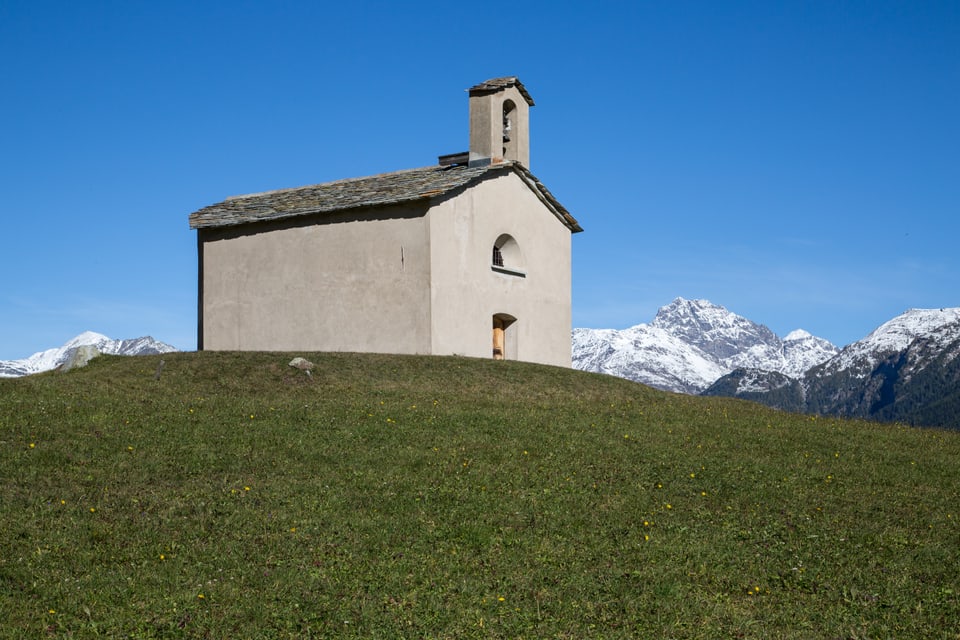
xmin=0 ymin=0 xmax=960 ymax=359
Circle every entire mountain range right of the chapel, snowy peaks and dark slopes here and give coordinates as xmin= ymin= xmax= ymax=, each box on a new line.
xmin=573 ymin=298 xmax=960 ymax=429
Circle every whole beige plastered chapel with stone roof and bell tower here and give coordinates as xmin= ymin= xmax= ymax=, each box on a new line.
xmin=189 ymin=77 xmax=582 ymax=367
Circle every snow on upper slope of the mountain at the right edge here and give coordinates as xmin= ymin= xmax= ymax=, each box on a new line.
xmin=817 ymin=307 xmax=960 ymax=377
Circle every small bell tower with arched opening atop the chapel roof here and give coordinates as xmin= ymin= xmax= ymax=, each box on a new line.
xmin=468 ymin=76 xmax=533 ymax=168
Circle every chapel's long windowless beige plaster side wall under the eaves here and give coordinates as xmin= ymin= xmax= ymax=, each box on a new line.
xmin=200 ymin=206 xmax=430 ymax=353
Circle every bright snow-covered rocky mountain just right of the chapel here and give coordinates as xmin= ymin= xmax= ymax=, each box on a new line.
xmin=573 ymin=298 xmax=839 ymax=393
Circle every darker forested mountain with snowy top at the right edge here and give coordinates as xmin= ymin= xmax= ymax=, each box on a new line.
xmin=704 ymin=308 xmax=960 ymax=428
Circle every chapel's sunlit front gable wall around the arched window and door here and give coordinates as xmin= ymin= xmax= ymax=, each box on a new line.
xmin=428 ymin=173 xmax=571 ymax=367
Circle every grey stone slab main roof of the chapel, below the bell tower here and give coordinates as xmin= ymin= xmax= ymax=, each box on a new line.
xmin=190 ymin=162 xmax=583 ymax=233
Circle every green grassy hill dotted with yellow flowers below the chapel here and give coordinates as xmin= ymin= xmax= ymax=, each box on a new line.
xmin=0 ymin=353 xmax=960 ymax=638
